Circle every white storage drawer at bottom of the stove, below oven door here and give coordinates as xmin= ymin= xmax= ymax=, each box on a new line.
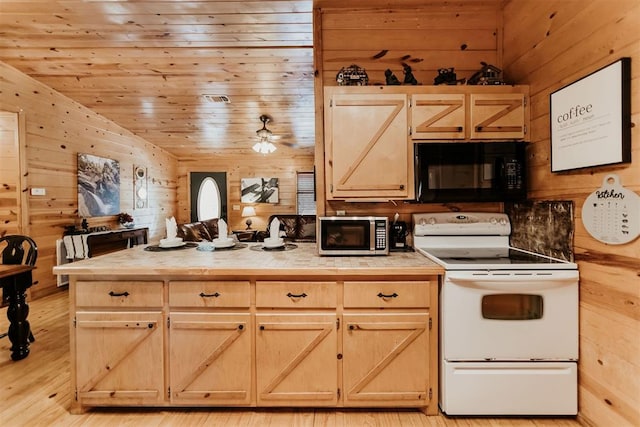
xmin=440 ymin=361 xmax=578 ymax=415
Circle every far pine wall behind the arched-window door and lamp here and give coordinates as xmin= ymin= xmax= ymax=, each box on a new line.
xmin=176 ymin=154 xmax=314 ymax=231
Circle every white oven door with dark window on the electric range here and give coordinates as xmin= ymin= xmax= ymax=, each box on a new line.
xmin=440 ymin=270 xmax=578 ymax=361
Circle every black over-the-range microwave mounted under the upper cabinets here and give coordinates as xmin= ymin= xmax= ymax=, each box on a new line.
xmin=414 ymin=141 xmax=527 ymax=203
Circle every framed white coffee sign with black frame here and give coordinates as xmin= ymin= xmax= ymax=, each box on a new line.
xmin=550 ymin=58 xmax=631 ymax=172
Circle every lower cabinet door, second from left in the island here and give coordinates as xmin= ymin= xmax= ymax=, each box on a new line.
xmin=168 ymin=312 xmax=253 ymax=405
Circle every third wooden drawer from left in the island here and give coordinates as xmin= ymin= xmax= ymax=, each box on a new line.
xmin=256 ymin=281 xmax=338 ymax=308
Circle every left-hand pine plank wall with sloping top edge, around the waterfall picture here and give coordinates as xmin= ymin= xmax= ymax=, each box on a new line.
xmin=0 ymin=62 xmax=176 ymax=298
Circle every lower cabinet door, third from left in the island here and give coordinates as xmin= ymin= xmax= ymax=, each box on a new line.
xmin=256 ymin=313 xmax=338 ymax=406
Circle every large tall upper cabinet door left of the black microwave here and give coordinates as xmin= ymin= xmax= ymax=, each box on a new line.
xmin=325 ymin=87 xmax=413 ymax=199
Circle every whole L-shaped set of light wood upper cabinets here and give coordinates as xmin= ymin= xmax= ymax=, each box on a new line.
xmin=324 ymin=85 xmax=529 ymax=201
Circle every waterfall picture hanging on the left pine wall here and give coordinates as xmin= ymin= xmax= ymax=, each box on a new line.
xmin=78 ymin=153 xmax=120 ymax=217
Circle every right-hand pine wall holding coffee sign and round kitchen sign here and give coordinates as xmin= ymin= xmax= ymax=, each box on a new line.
xmin=504 ymin=0 xmax=640 ymax=426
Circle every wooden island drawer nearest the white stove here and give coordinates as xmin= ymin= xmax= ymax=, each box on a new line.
xmin=344 ymin=281 xmax=432 ymax=308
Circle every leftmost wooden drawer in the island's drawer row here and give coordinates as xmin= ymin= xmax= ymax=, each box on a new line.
xmin=76 ymin=280 xmax=162 ymax=308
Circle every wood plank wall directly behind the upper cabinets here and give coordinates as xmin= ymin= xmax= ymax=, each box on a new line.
xmin=314 ymin=0 xmax=503 ymax=231
